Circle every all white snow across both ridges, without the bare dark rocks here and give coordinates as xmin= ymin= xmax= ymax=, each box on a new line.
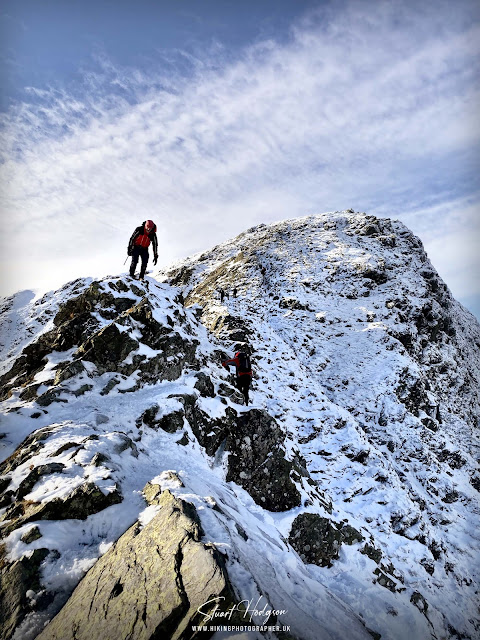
xmin=0 ymin=213 xmax=480 ymax=640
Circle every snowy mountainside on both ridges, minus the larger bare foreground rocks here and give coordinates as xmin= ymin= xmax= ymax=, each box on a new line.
xmin=0 ymin=212 xmax=480 ymax=640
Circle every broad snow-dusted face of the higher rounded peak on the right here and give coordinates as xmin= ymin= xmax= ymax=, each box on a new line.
xmin=160 ymin=211 xmax=480 ymax=638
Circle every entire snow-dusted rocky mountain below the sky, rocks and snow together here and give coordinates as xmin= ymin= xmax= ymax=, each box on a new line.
xmin=0 ymin=210 xmax=480 ymax=640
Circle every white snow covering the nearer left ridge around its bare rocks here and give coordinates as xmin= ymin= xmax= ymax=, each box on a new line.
xmin=1 ymin=278 xmax=369 ymax=639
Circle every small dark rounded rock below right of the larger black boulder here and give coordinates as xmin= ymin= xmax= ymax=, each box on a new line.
xmin=288 ymin=513 xmax=342 ymax=567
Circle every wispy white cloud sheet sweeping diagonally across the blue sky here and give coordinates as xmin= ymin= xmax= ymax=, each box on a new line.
xmin=0 ymin=2 xmax=480 ymax=316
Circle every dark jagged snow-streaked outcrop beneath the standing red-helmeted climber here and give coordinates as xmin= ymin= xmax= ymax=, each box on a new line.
xmin=0 ymin=280 xmax=198 ymax=407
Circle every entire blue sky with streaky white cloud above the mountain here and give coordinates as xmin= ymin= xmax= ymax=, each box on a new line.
xmin=0 ymin=0 xmax=480 ymax=317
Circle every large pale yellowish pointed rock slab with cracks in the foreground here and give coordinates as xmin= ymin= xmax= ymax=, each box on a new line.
xmin=38 ymin=491 xmax=240 ymax=640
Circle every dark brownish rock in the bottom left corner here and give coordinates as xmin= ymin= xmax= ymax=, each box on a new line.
xmin=0 ymin=549 xmax=48 ymax=640
